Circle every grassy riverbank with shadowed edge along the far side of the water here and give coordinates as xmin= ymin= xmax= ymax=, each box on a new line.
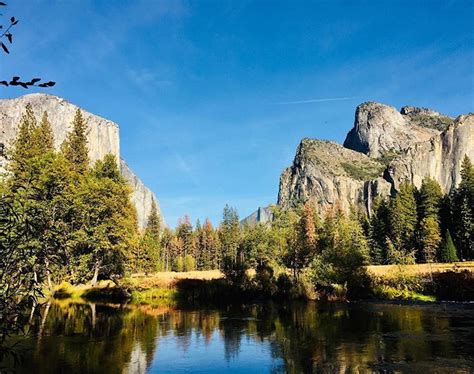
xmin=53 ymin=262 xmax=474 ymax=305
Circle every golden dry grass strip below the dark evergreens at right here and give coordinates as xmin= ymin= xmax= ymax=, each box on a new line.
xmin=367 ymin=261 xmax=474 ymax=276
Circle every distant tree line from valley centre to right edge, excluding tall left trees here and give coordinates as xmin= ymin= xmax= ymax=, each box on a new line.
xmin=133 ymin=156 xmax=474 ymax=276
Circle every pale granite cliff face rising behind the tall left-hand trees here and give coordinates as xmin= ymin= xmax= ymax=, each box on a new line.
xmin=0 ymin=94 xmax=159 ymax=229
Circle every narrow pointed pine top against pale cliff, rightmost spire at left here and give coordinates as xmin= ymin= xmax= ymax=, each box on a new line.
xmin=61 ymin=109 xmax=89 ymax=174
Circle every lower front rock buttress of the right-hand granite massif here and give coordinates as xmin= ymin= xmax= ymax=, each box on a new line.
xmin=278 ymin=139 xmax=390 ymax=212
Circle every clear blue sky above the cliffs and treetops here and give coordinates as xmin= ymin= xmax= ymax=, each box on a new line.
xmin=0 ymin=0 xmax=474 ymax=227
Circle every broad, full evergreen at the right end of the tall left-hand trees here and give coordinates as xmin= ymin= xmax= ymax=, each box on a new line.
xmin=74 ymin=156 xmax=136 ymax=284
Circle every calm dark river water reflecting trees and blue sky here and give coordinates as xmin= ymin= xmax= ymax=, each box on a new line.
xmin=2 ymin=300 xmax=474 ymax=374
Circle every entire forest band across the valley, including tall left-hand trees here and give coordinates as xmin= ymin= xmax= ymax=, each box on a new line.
xmin=0 ymin=106 xmax=474 ymax=350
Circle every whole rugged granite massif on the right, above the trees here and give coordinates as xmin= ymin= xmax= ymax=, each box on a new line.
xmin=278 ymin=102 xmax=474 ymax=213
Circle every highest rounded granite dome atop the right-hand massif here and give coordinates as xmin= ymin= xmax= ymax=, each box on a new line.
xmin=344 ymin=102 xmax=440 ymax=158
